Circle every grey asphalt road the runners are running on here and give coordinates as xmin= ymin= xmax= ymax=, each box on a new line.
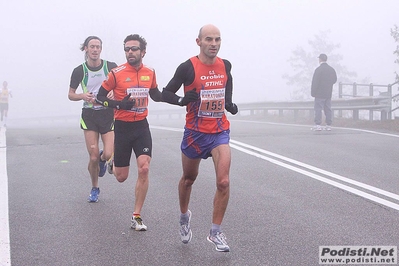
xmin=3 ymin=118 xmax=399 ymax=266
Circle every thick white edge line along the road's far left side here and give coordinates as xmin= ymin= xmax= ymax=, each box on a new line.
xmin=0 ymin=127 xmax=11 ymax=266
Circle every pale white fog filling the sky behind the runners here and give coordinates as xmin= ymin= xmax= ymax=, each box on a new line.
xmin=0 ymin=0 xmax=399 ymax=119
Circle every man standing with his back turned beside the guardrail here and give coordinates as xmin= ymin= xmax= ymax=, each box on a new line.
xmin=311 ymin=54 xmax=337 ymax=131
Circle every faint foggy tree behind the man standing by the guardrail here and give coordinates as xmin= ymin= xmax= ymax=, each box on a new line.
xmin=283 ymin=30 xmax=357 ymax=100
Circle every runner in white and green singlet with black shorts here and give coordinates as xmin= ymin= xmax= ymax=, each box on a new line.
xmin=68 ymin=36 xmax=117 ymax=202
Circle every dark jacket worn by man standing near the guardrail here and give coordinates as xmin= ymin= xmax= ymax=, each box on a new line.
xmin=311 ymin=62 xmax=337 ymax=99
